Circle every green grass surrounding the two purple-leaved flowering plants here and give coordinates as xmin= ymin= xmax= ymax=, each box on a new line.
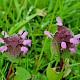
xmin=0 ymin=0 xmax=80 ymax=80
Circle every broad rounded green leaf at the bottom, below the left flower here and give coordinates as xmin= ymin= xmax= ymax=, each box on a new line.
xmin=14 ymin=67 xmax=31 ymax=80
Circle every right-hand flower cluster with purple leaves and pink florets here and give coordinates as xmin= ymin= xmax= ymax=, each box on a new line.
xmin=44 ymin=17 xmax=80 ymax=53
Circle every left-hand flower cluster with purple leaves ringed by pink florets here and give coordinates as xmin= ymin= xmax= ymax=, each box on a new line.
xmin=0 ymin=30 xmax=31 ymax=57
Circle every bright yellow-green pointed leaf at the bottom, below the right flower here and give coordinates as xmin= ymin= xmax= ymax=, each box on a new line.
xmin=46 ymin=64 xmax=58 ymax=80
